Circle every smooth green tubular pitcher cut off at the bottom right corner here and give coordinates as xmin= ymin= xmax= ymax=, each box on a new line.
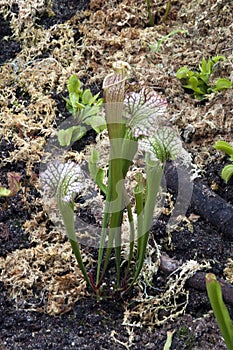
xmin=206 ymin=273 xmax=233 ymax=350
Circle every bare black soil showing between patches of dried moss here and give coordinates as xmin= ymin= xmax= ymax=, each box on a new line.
xmin=0 ymin=0 xmax=233 ymax=350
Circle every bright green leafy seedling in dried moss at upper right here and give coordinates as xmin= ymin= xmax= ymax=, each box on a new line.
xmin=176 ymin=56 xmax=232 ymax=100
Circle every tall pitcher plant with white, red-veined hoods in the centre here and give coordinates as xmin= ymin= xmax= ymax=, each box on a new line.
xmin=40 ymin=62 xmax=186 ymax=297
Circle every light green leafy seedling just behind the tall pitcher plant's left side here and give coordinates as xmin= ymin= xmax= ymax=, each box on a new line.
xmin=58 ymin=75 xmax=106 ymax=146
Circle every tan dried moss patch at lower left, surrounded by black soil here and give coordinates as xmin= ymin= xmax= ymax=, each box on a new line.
xmin=0 ymin=242 xmax=89 ymax=315
